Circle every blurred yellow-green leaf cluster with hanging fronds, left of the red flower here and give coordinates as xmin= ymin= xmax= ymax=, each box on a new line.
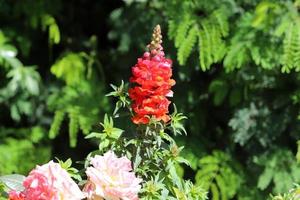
xmin=48 ymin=81 xmax=106 ymax=147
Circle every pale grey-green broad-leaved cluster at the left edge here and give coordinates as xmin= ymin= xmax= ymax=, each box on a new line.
xmin=0 ymin=32 xmax=41 ymax=121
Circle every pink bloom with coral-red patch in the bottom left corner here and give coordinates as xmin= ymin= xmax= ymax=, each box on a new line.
xmin=9 ymin=161 xmax=85 ymax=200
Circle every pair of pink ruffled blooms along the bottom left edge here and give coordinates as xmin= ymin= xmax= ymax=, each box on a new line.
xmin=9 ymin=151 xmax=142 ymax=200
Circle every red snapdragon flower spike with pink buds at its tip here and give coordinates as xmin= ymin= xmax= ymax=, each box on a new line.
xmin=128 ymin=25 xmax=175 ymax=124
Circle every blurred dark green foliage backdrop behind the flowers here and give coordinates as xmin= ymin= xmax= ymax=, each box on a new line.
xmin=0 ymin=0 xmax=300 ymax=200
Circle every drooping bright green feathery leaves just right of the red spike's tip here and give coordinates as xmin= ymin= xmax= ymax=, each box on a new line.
xmin=168 ymin=1 xmax=229 ymax=71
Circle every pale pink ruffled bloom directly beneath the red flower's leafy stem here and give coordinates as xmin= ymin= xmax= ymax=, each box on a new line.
xmin=83 ymin=151 xmax=142 ymax=200
